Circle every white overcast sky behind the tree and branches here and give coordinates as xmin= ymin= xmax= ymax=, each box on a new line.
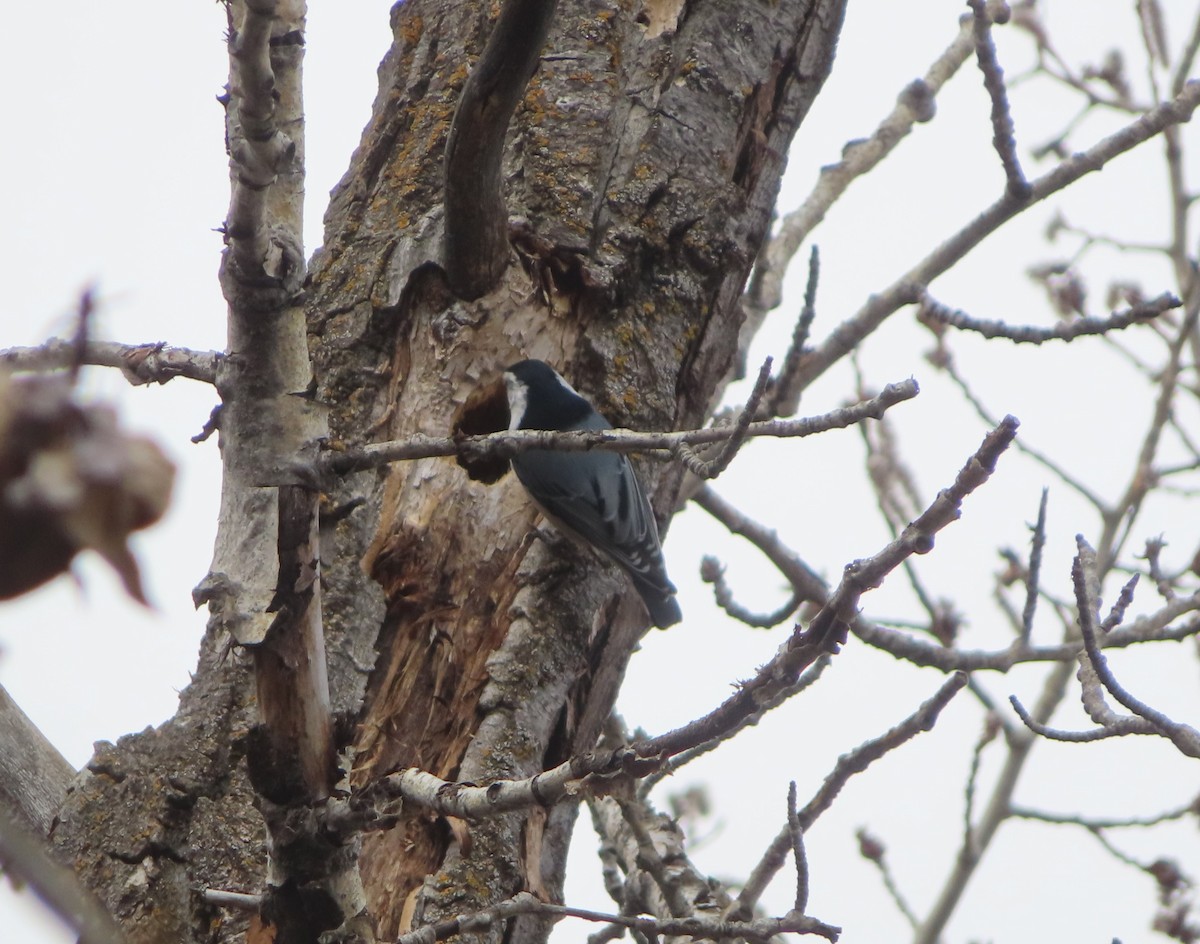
xmin=0 ymin=0 xmax=1200 ymax=944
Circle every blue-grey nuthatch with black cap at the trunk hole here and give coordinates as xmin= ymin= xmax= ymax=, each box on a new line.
xmin=504 ymin=360 xmax=683 ymax=629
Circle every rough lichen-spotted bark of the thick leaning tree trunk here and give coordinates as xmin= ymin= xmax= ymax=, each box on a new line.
xmin=37 ymin=0 xmax=844 ymax=942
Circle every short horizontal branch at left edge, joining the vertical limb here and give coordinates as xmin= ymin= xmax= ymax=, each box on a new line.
xmin=0 ymin=338 xmax=223 ymax=386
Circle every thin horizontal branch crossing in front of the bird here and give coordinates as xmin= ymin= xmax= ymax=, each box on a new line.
xmin=320 ymin=379 xmax=919 ymax=475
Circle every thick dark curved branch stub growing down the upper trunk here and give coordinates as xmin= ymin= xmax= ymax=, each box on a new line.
xmin=443 ymin=0 xmax=557 ymax=300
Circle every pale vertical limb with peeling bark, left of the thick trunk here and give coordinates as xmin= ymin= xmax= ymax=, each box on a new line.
xmin=204 ymin=0 xmax=350 ymax=944
